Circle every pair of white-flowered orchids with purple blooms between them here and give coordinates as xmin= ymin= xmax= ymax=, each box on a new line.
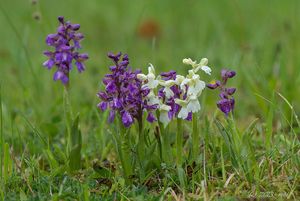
xmin=137 ymin=58 xmax=211 ymax=167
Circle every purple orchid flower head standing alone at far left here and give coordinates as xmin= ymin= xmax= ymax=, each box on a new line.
xmin=43 ymin=16 xmax=89 ymax=84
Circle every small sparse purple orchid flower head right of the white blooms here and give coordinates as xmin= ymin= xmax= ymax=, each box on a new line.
xmin=206 ymin=70 xmax=236 ymax=116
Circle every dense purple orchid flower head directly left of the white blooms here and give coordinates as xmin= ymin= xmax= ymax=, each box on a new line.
xmin=98 ymin=53 xmax=148 ymax=127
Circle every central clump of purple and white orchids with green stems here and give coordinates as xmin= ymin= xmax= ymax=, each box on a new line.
xmin=97 ymin=53 xmax=235 ymax=181
